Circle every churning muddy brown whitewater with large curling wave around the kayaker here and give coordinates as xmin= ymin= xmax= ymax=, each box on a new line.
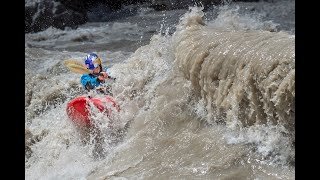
xmin=25 ymin=1 xmax=295 ymax=179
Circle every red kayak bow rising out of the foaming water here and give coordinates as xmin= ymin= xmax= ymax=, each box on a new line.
xmin=67 ymin=96 xmax=120 ymax=126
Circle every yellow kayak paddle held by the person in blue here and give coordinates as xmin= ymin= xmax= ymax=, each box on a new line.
xmin=63 ymin=59 xmax=116 ymax=80
